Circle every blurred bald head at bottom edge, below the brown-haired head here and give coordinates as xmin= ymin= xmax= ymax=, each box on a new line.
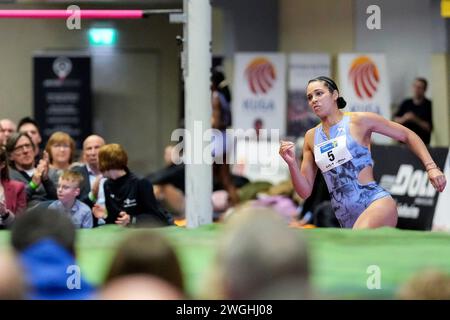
xmin=97 ymin=274 xmax=184 ymax=300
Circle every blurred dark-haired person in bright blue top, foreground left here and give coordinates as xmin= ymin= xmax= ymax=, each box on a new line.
xmin=11 ymin=209 xmax=94 ymax=300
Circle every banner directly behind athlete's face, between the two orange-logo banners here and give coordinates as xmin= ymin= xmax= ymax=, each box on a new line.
xmin=287 ymin=53 xmax=331 ymax=138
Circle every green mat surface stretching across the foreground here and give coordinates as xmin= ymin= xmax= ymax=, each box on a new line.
xmin=0 ymin=224 xmax=450 ymax=299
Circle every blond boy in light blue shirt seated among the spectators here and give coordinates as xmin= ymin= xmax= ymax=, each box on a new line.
xmin=49 ymin=171 xmax=93 ymax=228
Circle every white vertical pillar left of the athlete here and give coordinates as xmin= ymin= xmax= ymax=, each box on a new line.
xmin=182 ymin=0 xmax=212 ymax=228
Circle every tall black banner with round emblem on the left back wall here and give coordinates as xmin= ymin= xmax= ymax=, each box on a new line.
xmin=33 ymin=53 xmax=92 ymax=148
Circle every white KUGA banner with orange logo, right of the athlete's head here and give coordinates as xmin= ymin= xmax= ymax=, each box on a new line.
xmin=338 ymin=53 xmax=392 ymax=144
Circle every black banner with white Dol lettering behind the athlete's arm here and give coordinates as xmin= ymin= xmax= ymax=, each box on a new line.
xmin=371 ymin=145 xmax=448 ymax=230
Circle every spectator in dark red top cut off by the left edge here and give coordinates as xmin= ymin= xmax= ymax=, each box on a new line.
xmin=0 ymin=146 xmax=27 ymax=229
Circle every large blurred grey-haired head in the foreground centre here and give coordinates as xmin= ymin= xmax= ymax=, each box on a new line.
xmin=211 ymin=208 xmax=311 ymax=300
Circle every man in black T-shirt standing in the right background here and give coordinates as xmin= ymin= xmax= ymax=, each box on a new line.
xmin=394 ymin=78 xmax=433 ymax=145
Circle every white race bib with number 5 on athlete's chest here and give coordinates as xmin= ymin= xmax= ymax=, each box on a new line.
xmin=314 ymin=135 xmax=353 ymax=172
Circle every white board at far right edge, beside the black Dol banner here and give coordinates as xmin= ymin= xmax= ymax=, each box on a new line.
xmin=433 ymin=152 xmax=450 ymax=231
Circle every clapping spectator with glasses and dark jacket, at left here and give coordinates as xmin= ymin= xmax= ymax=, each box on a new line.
xmin=6 ymin=132 xmax=56 ymax=207
